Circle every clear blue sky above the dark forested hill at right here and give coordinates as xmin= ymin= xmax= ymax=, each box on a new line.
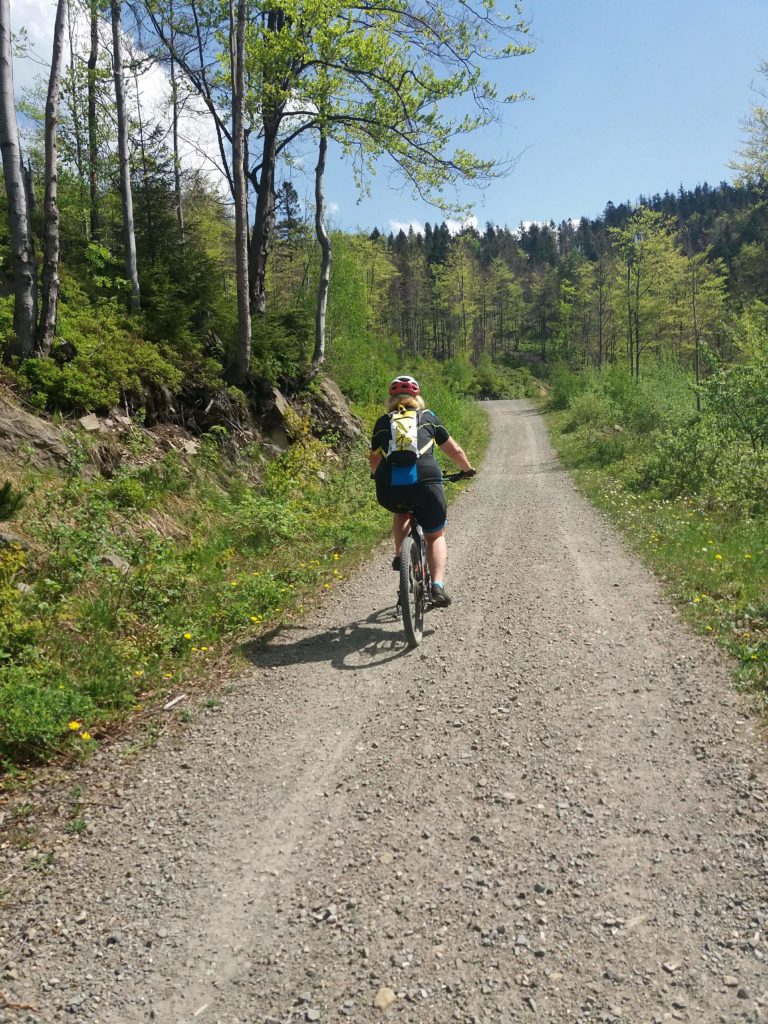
xmin=328 ymin=0 xmax=768 ymax=230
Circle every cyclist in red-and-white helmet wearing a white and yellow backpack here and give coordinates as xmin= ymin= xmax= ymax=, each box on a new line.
xmin=369 ymin=374 xmax=475 ymax=607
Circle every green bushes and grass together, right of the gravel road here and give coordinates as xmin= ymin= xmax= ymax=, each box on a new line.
xmin=551 ymin=352 xmax=768 ymax=688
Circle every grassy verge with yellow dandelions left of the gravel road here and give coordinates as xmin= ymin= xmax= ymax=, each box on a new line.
xmin=0 ymin=398 xmax=487 ymax=770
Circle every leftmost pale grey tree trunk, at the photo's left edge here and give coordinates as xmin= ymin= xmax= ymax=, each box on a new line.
xmin=0 ymin=0 xmax=37 ymax=357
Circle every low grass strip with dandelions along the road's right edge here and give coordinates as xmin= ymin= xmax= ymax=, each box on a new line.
xmin=547 ymin=395 xmax=768 ymax=705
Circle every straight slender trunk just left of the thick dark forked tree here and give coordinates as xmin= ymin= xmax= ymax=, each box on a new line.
xmin=226 ymin=0 xmax=251 ymax=383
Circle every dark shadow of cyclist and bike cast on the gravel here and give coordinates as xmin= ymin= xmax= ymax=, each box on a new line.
xmin=244 ymin=607 xmax=432 ymax=672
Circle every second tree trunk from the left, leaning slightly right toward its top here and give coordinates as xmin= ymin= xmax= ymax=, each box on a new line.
xmin=37 ymin=0 xmax=67 ymax=355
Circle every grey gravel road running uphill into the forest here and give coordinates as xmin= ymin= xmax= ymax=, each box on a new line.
xmin=0 ymin=401 xmax=768 ymax=1024
